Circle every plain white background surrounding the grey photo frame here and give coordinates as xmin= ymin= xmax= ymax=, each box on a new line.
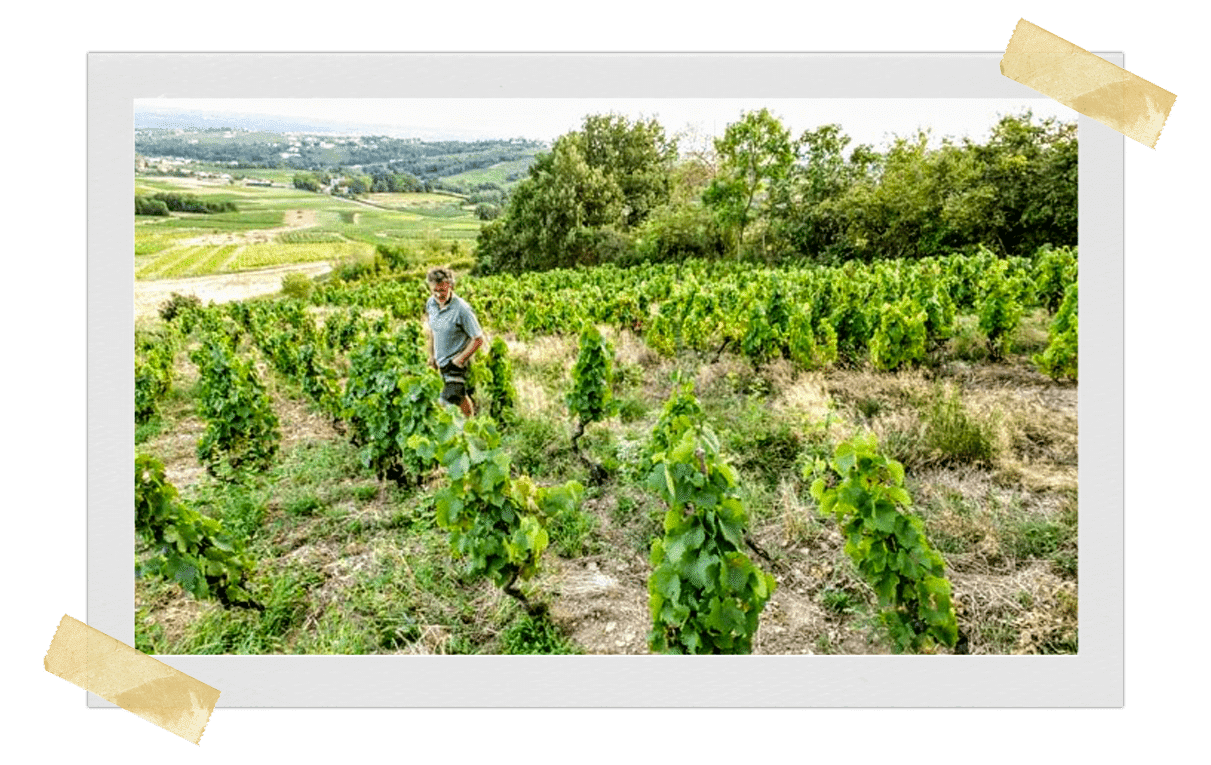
xmin=9 ymin=0 xmax=1209 ymax=763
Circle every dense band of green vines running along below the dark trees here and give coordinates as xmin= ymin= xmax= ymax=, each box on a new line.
xmin=312 ymin=243 xmax=1077 ymax=379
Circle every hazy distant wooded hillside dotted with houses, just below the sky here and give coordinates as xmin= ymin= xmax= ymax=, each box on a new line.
xmin=134 ymin=127 xmax=546 ymax=191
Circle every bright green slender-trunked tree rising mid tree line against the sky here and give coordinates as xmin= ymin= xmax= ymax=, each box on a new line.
xmin=702 ymin=109 xmax=794 ymax=260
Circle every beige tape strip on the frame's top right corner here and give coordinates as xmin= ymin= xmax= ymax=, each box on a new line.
xmin=1000 ymin=18 xmax=1177 ymax=149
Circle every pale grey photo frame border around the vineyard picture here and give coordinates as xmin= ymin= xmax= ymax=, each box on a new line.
xmin=87 ymin=52 xmax=1125 ymax=708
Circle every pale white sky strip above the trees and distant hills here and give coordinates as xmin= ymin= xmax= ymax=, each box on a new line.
xmin=134 ymin=98 xmax=1078 ymax=149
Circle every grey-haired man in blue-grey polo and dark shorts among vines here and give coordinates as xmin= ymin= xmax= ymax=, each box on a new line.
xmin=424 ymin=269 xmax=483 ymax=416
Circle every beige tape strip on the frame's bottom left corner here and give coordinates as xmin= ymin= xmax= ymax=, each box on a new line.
xmin=42 ymin=615 xmax=219 ymax=744
